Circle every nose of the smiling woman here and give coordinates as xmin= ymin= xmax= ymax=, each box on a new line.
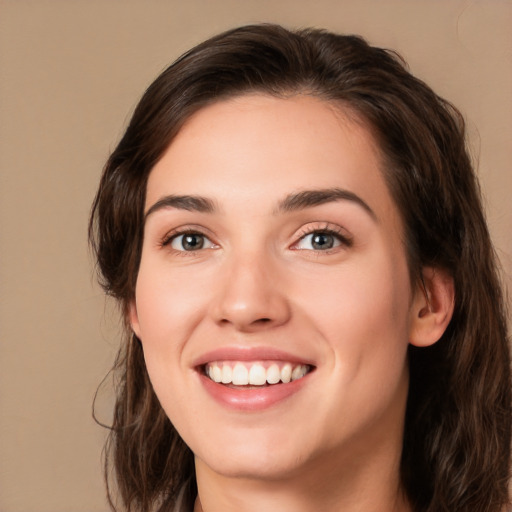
xmin=213 ymin=251 xmax=291 ymax=332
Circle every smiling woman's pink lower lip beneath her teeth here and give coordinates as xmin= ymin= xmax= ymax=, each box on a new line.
xmin=200 ymin=374 xmax=309 ymax=411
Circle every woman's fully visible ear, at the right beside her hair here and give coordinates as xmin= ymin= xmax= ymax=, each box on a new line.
xmin=409 ymin=267 xmax=455 ymax=347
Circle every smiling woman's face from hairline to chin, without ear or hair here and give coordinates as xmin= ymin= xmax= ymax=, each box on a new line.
xmin=131 ymin=95 xmax=413 ymax=479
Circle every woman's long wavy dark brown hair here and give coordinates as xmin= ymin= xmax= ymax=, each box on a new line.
xmin=90 ymin=25 xmax=511 ymax=512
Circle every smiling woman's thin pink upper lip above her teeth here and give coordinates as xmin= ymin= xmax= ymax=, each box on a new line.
xmin=193 ymin=346 xmax=315 ymax=367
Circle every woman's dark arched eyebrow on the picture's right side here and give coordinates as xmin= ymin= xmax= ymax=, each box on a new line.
xmin=276 ymin=188 xmax=377 ymax=221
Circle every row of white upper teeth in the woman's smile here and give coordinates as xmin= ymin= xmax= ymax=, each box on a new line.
xmin=206 ymin=363 xmax=308 ymax=386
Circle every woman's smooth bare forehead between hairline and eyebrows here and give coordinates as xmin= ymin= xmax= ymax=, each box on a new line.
xmin=146 ymin=94 xmax=392 ymax=220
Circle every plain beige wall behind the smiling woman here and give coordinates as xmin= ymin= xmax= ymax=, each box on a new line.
xmin=0 ymin=0 xmax=512 ymax=512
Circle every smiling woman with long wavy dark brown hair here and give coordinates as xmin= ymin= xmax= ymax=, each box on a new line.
xmin=90 ymin=25 xmax=511 ymax=512
